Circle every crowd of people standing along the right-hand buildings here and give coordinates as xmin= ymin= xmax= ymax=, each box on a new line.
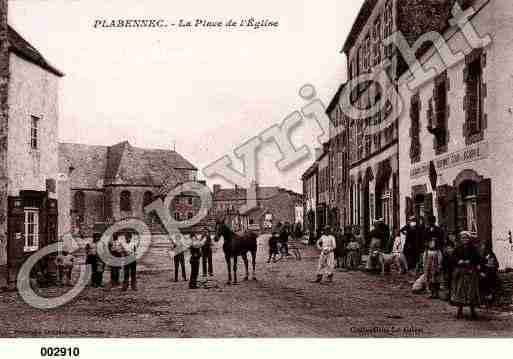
xmin=314 ymin=215 xmax=499 ymax=318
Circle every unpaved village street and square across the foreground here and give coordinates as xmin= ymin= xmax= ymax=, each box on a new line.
xmin=0 ymin=237 xmax=513 ymax=337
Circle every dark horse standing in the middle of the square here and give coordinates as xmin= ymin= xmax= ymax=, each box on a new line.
xmin=216 ymin=221 xmax=258 ymax=284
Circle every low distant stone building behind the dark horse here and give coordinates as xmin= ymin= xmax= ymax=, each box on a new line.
xmin=213 ymin=184 xmax=303 ymax=231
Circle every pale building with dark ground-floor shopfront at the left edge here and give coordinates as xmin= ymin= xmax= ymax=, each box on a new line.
xmin=0 ymin=1 xmax=63 ymax=281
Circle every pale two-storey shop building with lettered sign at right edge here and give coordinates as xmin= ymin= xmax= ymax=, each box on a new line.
xmin=399 ymin=0 xmax=513 ymax=268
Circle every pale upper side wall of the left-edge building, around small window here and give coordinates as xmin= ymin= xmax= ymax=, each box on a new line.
xmin=7 ymin=53 xmax=59 ymax=198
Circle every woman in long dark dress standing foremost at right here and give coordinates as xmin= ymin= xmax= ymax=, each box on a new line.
xmin=451 ymin=231 xmax=481 ymax=319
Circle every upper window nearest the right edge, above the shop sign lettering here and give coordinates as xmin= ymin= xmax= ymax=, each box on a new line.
xmin=463 ymin=49 xmax=486 ymax=145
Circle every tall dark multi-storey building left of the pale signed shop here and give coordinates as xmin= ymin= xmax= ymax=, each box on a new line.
xmin=341 ymin=0 xmax=474 ymax=242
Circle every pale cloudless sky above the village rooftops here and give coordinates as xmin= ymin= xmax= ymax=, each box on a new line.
xmin=9 ymin=0 xmax=363 ymax=192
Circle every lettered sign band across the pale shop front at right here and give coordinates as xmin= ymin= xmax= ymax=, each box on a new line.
xmin=410 ymin=142 xmax=488 ymax=178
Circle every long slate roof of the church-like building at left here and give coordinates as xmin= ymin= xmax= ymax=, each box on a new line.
xmin=59 ymin=141 xmax=196 ymax=189
